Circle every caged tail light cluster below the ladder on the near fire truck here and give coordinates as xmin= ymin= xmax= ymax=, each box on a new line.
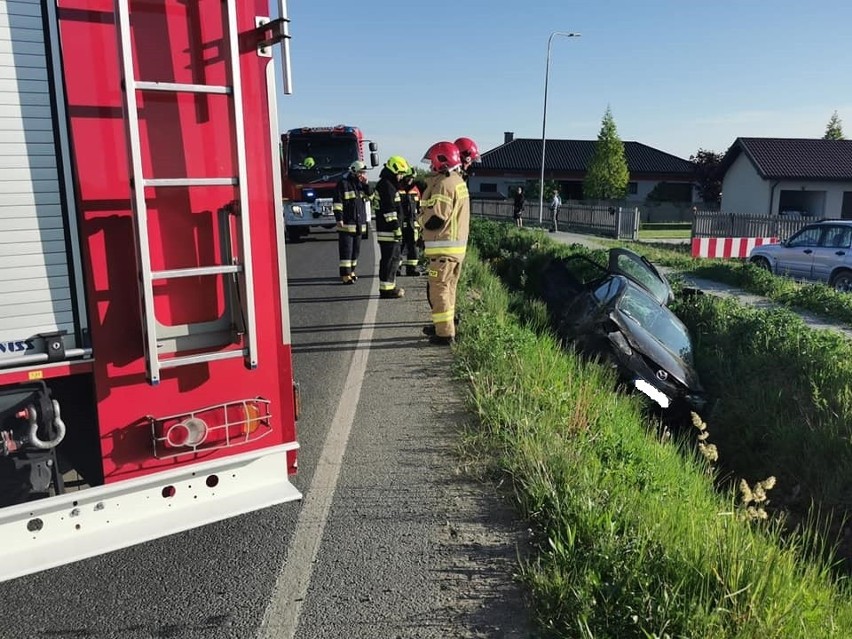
xmin=148 ymin=398 xmax=272 ymax=459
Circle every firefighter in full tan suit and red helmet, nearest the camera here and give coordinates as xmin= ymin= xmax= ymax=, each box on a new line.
xmin=420 ymin=142 xmax=470 ymax=344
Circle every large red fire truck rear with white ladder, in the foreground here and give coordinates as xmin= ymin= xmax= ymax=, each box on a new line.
xmin=0 ymin=0 xmax=301 ymax=579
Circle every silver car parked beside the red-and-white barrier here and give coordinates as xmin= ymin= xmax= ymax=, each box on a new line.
xmin=748 ymin=220 xmax=852 ymax=291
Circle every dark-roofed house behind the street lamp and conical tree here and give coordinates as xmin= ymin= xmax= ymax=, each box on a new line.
xmin=469 ymin=132 xmax=696 ymax=202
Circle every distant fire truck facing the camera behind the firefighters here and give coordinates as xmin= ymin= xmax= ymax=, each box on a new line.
xmin=281 ymin=124 xmax=379 ymax=241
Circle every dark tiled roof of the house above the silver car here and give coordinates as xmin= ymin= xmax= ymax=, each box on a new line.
xmin=721 ymin=138 xmax=852 ymax=181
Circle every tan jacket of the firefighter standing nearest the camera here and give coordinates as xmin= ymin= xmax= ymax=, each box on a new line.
xmin=420 ymin=171 xmax=470 ymax=261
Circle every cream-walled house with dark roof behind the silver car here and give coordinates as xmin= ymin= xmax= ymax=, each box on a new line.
xmin=720 ymin=138 xmax=852 ymax=219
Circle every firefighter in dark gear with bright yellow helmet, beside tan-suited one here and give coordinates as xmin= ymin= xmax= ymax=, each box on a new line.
xmin=376 ymin=155 xmax=410 ymax=299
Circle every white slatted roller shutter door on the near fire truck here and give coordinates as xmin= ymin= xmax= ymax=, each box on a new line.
xmin=0 ymin=0 xmax=85 ymax=370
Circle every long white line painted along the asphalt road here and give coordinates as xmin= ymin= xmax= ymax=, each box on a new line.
xmin=257 ymin=245 xmax=379 ymax=639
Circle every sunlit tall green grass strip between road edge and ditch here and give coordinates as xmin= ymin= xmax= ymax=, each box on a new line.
xmin=456 ymin=220 xmax=852 ymax=639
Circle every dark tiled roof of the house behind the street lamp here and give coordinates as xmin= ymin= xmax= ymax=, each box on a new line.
xmin=481 ymin=138 xmax=695 ymax=176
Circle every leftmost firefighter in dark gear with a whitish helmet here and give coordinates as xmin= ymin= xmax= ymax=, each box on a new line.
xmin=332 ymin=160 xmax=370 ymax=284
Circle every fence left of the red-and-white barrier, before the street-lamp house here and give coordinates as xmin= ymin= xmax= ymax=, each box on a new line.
xmin=470 ymin=200 xmax=640 ymax=240
